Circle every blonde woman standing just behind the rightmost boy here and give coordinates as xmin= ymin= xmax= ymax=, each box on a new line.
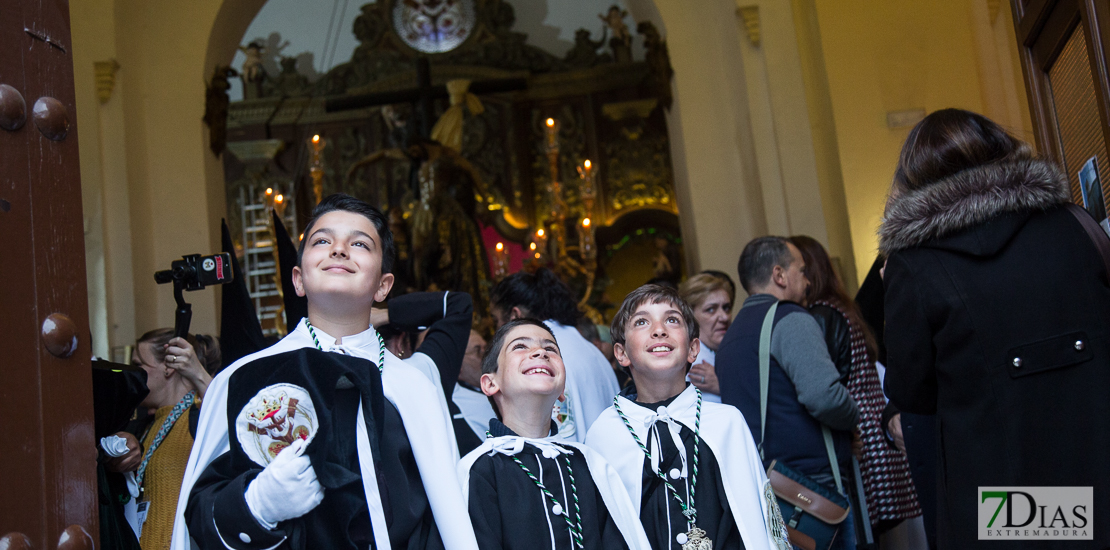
xmin=678 ymin=273 xmax=736 ymax=403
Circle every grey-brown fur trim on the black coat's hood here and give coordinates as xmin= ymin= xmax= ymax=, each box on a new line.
xmin=879 ymin=159 xmax=1071 ymax=256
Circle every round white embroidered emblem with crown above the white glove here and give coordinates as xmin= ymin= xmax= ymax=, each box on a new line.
xmin=235 ymin=383 xmax=320 ymax=467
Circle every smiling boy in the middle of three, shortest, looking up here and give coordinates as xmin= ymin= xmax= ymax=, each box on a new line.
xmin=458 ymin=318 xmax=649 ymax=550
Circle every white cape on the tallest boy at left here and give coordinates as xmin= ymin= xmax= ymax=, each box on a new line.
xmin=170 ymin=320 xmax=477 ymax=550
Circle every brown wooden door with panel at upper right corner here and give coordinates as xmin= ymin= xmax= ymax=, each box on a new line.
xmin=1011 ymin=0 xmax=1110 ymax=202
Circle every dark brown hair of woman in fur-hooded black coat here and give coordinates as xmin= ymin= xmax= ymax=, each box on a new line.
xmin=895 ymin=109 xmax=1032 ymax=191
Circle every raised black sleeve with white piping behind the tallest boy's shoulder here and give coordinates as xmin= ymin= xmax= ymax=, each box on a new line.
xmin=387 ymin=292 xmax=474 ymax=401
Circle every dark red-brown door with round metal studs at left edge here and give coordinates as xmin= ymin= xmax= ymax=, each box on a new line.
xmin=0 ymin=0 xmax=98 ymax=549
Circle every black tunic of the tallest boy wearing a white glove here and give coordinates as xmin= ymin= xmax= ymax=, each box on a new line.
xmin=185 ymin=348 xmax=443 ymax=550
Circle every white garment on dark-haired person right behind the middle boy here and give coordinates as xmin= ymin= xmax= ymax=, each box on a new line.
xmin=544 ymin=320 xmax=620 ymax=443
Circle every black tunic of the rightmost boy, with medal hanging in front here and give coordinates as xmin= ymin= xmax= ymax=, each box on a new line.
xmin=629 ymin=394 xmax=744 ymax=550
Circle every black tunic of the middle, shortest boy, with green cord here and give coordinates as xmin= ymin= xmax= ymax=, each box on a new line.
xmin=470 ymin=419 xmax=628 ymax=550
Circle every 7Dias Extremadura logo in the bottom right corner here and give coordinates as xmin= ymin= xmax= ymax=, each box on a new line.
xmin=979 ymin=487 xmax=1094 ymax=540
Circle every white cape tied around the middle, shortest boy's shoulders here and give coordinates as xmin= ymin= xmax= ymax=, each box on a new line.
xmin=458 ymin=436 xmax=652 ymax=550
